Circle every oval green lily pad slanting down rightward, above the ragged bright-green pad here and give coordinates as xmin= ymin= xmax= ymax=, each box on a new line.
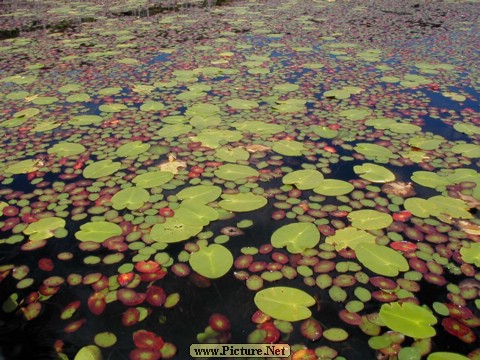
xmin=355 ymin=243 xmax=409 ymax=276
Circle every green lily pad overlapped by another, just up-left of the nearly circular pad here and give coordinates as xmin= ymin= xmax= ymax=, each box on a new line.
xmin=150 ymin=217 xmax=203 ymax=243
